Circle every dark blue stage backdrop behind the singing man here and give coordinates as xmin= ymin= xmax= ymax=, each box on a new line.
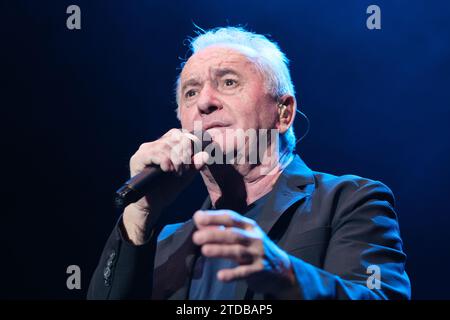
xmin=0 ymin=0 xmax=450 ymax=299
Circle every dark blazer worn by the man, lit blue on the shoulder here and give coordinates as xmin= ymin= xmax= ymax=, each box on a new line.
xmin=88 ymin=156 xmax=411 ymax=299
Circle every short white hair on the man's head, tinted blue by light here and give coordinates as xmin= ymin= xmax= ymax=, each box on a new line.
xmin=175 ymin=27 xmax=296 ymax=153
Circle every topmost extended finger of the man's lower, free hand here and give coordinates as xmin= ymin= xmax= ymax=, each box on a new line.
xmin=193 ymin=210 xmax=255 ymax=230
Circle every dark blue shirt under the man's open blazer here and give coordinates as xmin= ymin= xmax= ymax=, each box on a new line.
xmin=189 ymin=192 xmax=270 ymax=300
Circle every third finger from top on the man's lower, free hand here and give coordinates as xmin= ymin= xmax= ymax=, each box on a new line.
xmin=202 ymin=244 xmax=254 ymax=264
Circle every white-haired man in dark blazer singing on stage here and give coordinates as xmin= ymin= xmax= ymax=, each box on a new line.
xmin=88 ymin=27 xmax=410 ymax=299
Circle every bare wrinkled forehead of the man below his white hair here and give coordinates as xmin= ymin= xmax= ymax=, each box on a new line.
xmin=181 ymin=46 xmax=257 ymax=81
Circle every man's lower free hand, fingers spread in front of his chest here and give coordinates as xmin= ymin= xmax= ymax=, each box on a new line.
xmin=192 ymin=210 xmax=296 ymax=294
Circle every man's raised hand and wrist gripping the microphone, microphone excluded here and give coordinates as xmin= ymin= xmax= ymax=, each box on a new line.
xmin=123 ymin=129 xmax=208 ymax=245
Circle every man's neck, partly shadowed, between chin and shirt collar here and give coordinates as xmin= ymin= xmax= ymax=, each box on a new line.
xmin=201 ymin=145 xmax=293 ymax=211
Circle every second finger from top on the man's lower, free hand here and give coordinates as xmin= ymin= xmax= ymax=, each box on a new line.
xmin=192 ymin=228 xmax=252 ymax=246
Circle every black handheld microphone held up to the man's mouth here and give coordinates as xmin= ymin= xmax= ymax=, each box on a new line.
xmin=114 ymin=131 xmax=212 ymax=209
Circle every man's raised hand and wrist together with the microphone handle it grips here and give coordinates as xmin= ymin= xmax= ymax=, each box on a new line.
xmin=117 ymin=129 xmax=210 ymax=244
